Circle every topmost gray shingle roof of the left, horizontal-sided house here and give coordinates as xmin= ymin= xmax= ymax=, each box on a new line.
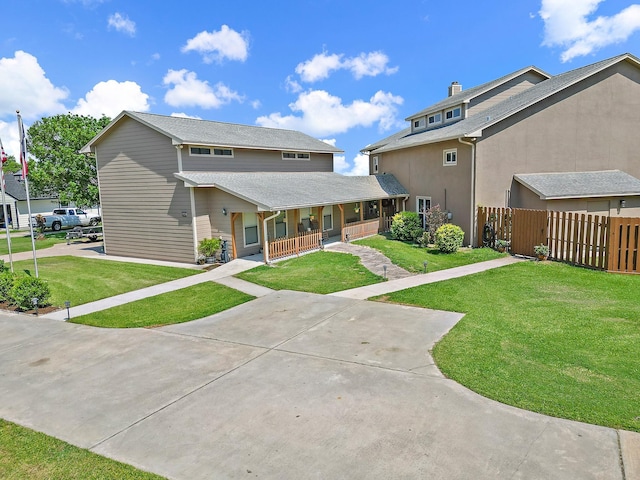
xmin=82 ymin=111 xmax=342 ymax=153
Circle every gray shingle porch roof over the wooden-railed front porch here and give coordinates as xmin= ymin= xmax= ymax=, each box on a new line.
xmin=175 ymin=172 xmax=409 ymax=211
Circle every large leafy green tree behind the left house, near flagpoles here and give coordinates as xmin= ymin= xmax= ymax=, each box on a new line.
xmin=28 ymin=113 xmax=111 ymax=207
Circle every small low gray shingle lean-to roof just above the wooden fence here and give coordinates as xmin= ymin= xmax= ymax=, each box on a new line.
xmin=513 ymin=170 xmax=640 ymax=200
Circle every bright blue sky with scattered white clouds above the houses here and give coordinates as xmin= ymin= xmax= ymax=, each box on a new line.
xmin=0 ymin=0 xmax=640 ymax=174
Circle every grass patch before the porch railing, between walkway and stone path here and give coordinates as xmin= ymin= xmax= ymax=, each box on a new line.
xmin=236 ymin=251 xmax=383 ymax=294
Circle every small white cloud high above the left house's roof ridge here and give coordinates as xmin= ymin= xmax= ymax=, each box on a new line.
xmin=182 ymin=25 xmax=249 ymax=63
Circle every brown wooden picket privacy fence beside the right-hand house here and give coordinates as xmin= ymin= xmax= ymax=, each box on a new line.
xmin=478 ymin=207 xmax=640 ymax=273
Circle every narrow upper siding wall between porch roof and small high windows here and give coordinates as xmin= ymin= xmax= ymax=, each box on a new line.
xmin=182 ymin=148 xmax=333 ymax=172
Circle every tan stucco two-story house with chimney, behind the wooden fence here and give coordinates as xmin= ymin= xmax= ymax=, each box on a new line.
xmin=363 ymin=54 xmax=640 ymax=244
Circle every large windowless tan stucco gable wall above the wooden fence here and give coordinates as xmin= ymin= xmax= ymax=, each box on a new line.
xmin=476 ymin=62 xmax=640 ymax=206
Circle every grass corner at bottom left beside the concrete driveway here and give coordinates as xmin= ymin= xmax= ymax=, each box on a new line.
xmin=0 ymin=420 xmax=164 ymax=480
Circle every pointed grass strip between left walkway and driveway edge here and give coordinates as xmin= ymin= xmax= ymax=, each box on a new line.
xmin=70 ymin=282 xmax=255 ymax=328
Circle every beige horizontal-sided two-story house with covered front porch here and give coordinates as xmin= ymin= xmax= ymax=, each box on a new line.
xmin=82 ymin=111 xmax=408 ymax=262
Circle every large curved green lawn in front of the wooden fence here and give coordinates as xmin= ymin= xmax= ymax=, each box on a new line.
xmin=380 ymin=262 xmax=640 ymax=432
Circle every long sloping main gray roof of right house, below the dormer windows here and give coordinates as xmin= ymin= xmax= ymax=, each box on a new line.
xmin=365 ymin=53 xmax=640 ymax=153
